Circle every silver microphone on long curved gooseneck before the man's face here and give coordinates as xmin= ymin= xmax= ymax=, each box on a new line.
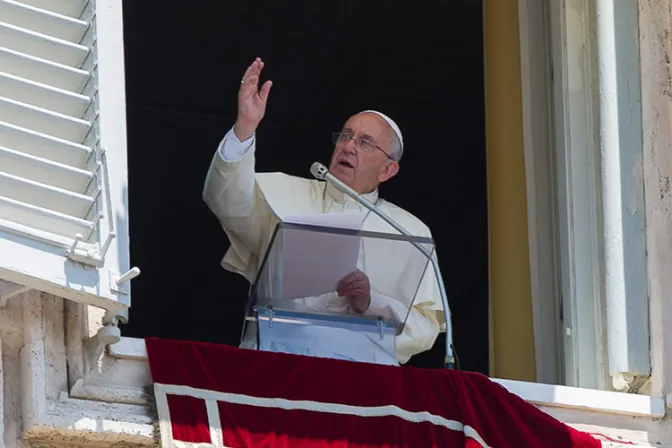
xmin=310 ymin=162 xmax=455 ymax=369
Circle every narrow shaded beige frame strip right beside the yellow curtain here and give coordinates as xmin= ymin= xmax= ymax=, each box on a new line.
xmin=518 ymin=0 xmax=565 ymax=384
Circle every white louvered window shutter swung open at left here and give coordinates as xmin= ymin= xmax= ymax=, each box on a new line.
xmin=0 ymin=0 xmax=138 ymax=320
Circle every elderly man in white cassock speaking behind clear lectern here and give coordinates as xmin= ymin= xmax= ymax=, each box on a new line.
xmin=203 ymin=58 xmax=445 ymax=365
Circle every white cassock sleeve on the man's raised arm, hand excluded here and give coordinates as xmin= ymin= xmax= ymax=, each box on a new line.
xmin=203 ymin=129 xmax=277 ymax=282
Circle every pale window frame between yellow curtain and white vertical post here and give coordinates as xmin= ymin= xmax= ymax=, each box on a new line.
xmin=519 ymin=0 xmax=611 ymax=390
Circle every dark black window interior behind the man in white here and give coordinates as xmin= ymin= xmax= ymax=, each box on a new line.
xmin=122 ymin=0 xmax=488 ymax=374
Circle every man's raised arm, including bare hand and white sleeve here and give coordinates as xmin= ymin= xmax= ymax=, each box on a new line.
xmin=203 ymin=58 xmax=275 ymax=280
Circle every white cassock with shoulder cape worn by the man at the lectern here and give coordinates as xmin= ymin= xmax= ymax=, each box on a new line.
xmin=203 ymin=129 xmax=445 ymax=364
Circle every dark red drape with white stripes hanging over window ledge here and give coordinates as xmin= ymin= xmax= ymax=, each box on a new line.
xmin=146 ymin=338 xmax=601 ymax=448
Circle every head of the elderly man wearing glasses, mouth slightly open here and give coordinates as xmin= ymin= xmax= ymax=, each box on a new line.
xmin=329 ymin=113 xmax=399 ymax=194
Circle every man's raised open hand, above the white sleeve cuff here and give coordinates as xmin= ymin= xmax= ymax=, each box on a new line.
xmin=233 ymin=58 xmax=273 ymax=142
